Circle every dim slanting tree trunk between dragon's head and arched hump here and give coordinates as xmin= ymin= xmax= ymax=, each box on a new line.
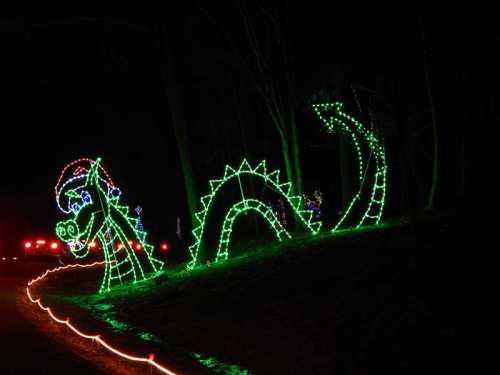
xmin=161 ymin=26 xmax=197 ymax=228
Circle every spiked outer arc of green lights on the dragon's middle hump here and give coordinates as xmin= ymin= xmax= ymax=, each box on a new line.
xmin=188 ymin=159 xmax=321 ymax=269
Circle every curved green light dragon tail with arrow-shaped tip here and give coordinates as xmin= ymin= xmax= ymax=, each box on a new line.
xmin=312 ymin=102 xmax=387 ymax=232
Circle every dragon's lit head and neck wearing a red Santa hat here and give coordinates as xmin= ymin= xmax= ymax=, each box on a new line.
xmin=55 ymin=159 xmax=164 ymax=292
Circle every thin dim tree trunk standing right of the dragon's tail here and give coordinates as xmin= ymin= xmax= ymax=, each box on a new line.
xmin=420 ymin=19 xmax=439 ymax=210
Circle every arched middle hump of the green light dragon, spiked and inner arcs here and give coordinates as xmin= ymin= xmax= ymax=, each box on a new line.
xmin=188 ymin=159 xmax=321 ymax=269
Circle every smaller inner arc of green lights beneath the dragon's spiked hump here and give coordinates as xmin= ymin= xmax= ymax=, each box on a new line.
xmin=216 ymin=199 xmax=292 ymax=262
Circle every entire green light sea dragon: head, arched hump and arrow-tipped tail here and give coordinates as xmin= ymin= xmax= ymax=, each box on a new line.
xmin=55 ymin=102 xmax=387 ymax=280
